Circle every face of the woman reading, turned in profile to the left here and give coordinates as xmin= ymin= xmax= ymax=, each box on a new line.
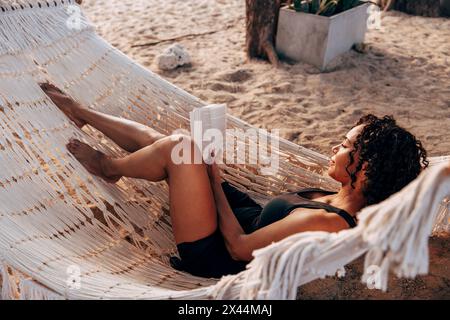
xmin=328 ymin=124 xmax=364 ymax=185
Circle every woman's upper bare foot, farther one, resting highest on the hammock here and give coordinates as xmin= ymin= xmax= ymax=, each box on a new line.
xmin=40 ymin=83 xmax=86 ymax=129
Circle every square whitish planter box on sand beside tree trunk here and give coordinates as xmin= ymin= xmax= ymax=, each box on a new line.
xmin=276 ymin=3 xmax=369 ymax=70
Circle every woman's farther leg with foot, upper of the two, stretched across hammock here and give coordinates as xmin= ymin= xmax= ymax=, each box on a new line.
xmin=41 ymin=84 xmax=165 ymax=152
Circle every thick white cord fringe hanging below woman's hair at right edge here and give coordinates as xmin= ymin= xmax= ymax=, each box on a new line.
xmin=360 ymin=165 xmax=450 ymax=291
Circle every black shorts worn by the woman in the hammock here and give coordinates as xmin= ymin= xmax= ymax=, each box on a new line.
xmin=170 ymin=182 xmax=262 ymax=278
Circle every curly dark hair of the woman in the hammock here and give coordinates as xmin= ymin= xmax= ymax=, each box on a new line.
xmin=346 ymin=114 xmax=429 ymax=205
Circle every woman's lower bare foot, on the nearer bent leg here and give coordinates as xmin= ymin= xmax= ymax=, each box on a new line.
xmin=67 ymin=139 xmax=121 ymax=183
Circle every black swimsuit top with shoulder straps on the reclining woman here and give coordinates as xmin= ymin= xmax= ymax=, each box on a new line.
xmin=259 ymin=188 xmax=356 ymax=228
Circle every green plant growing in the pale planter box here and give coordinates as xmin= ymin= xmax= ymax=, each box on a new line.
xmin=293 ymin=0 xmax=361 ymax=17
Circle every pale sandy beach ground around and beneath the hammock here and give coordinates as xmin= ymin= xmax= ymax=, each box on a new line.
xmin=78 ymin=0 xmax=450 ymax=299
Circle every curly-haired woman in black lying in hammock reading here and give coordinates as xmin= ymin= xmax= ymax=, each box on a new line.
xmin=42 ymin=84 xmax=428 ymax=277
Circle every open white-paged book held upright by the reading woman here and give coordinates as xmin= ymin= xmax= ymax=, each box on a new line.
xmin=189 ymin=104 xmax=227 ymax=163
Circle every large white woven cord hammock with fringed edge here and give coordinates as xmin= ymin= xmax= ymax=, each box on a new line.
xmin=0 ymin=0 xmax=450 ymax=299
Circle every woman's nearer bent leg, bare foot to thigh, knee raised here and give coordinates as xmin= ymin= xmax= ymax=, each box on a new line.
xmin=67 ymin=135 xmax=217 ymax=244
